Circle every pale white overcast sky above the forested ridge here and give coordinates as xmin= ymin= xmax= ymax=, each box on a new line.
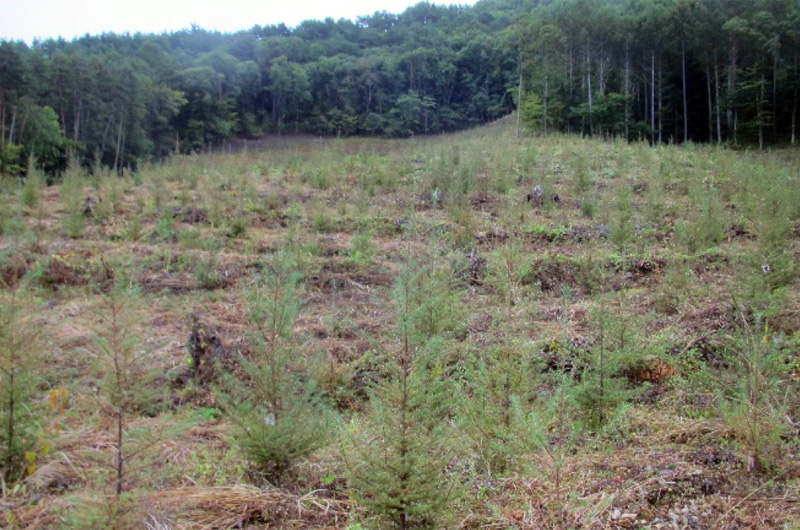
xmin=0 ymin=0 xmax=476 ymax=44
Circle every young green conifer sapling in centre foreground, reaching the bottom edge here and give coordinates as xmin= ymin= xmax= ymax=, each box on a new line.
xmin=345 ymin=262 xmax=454 ymax=530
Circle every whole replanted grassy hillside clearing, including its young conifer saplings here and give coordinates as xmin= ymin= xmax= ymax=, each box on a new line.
xmin=0 ymin=120 xmax=800 ymax=529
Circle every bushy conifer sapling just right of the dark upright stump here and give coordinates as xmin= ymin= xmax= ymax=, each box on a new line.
xmin=220 ymin=253 xmax=331 ymax=483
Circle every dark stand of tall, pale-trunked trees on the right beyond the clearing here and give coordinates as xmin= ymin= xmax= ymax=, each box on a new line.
xmin=505 ymin=0 xmax=800 ymax=147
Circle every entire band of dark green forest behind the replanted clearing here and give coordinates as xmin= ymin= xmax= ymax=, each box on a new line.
xmin=0 ymin=0 xmax=800 ymax=173
